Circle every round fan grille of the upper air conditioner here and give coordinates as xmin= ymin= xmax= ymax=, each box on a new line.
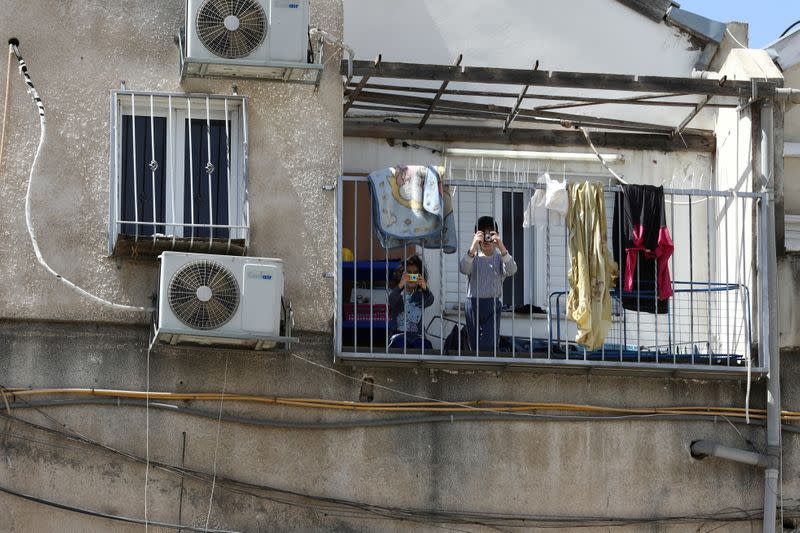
xmin=196 ymin=0 xmax=267 ymax=59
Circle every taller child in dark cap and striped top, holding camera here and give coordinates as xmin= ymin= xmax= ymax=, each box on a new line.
xmin=459 ymin=216 xmax=517 ymax=351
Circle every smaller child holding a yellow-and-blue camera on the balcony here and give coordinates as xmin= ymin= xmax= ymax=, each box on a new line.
xmin=389 ymin=255 xmax=433 ymax=349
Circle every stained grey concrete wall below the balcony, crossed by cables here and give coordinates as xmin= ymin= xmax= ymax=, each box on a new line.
xmin=0 ymin=322 xmax=776 ymax=531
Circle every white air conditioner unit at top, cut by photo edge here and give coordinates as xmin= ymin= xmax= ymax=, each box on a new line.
xmin=181 ymin=0 xmax=321 ymax=80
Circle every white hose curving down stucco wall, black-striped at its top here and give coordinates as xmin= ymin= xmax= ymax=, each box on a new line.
xmin=8 ymin=39 xmax=153 ymax=312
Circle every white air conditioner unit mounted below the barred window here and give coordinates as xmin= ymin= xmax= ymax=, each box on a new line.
xmin=153 ymin=252 xmax=291 ymax=349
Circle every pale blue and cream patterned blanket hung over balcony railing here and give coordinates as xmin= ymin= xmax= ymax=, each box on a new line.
xmin=367 ymin=166 xmax=457 ymax=253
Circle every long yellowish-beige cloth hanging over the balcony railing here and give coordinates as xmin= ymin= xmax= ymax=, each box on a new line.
xmin=567 ymin=182 xmax=618 ymax=350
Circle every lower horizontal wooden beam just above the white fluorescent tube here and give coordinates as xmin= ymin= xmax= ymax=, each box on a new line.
xmin=344 ymin=119 xmax=716 ymax=153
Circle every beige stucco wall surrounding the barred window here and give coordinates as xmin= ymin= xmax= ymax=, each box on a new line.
xmin=0 ymin=0 xmax=342 ymax=329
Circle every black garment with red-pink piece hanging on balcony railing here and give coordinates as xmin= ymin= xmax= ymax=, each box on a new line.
xmin=613 ymin=185 xmax=674 ymax=314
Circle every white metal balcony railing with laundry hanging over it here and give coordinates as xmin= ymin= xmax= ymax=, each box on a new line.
xmin=335 ymin=170 xmax=766 ymax=375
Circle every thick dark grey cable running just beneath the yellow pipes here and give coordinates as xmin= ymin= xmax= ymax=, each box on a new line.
xmin=9 ymin=398 xmax=800 ymax=433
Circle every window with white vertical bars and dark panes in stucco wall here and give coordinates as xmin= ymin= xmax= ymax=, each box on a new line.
xmin=109 ymin=91 xmax=249 ymax=256
